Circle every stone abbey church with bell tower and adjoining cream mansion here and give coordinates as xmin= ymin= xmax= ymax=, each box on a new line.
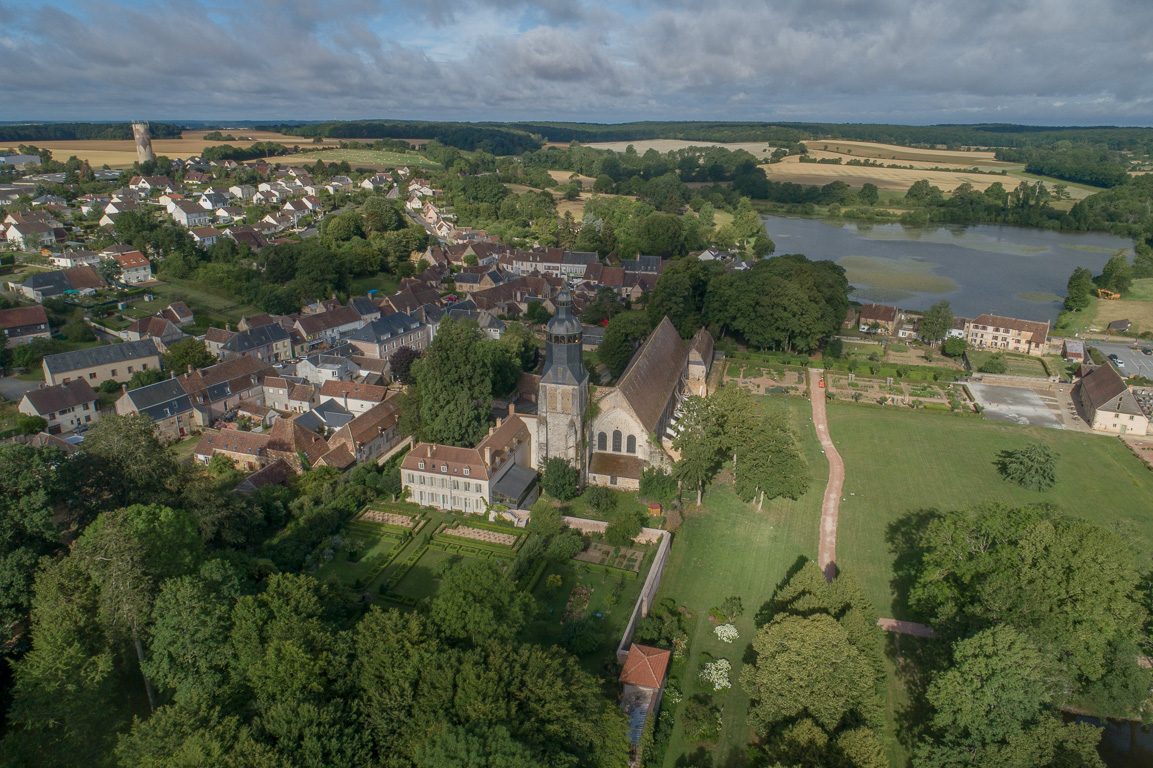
xmin=400 ymin=281 xmax=713 ymax=513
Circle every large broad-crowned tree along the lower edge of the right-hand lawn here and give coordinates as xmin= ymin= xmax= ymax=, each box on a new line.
xmin=910 ymin=505 xmax=1145 ymax=678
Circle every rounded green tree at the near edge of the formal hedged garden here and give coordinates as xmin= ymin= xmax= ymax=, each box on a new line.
xmin=429 ymin=559 xmax=533 ymax=643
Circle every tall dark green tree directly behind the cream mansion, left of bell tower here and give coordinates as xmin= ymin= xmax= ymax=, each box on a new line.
xmin=416 ymin=318 xmax=492 ymax=445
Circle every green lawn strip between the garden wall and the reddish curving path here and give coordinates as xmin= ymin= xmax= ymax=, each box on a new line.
xmin=657 ymin=397 xmax=829 ymax=768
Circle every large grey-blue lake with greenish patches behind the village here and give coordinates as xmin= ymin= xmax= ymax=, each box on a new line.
xmin=761 ymin=216 xmax=1133 ymax=322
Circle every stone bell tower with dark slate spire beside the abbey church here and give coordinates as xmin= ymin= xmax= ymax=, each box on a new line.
xmin=536 ymin=285 xmax=588 ymax=482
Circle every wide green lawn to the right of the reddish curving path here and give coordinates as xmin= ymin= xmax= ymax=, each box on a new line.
xmin=828 ymin=402 xmax=1153 ymax=620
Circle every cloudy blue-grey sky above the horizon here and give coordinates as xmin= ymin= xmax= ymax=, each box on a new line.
xmin=0 ymin=0 xmax=1153 ymax=126
